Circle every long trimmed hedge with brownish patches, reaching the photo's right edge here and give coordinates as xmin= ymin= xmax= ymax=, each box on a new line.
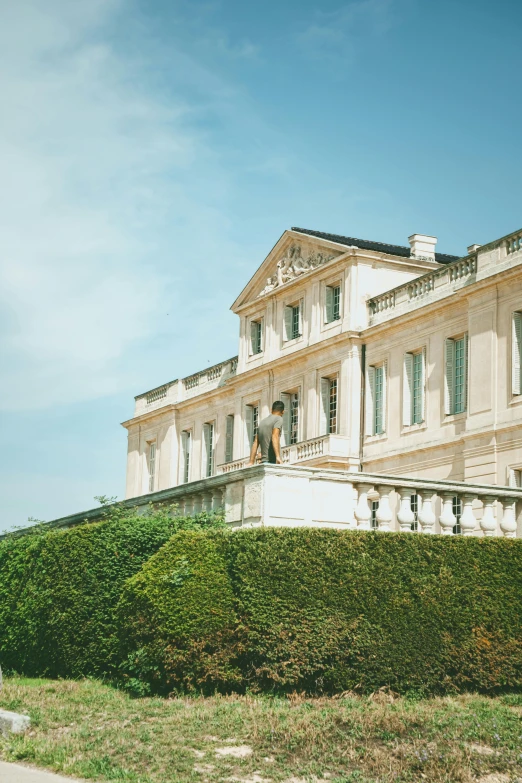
xmin=120 ymin=528 xmax=522 ymax=693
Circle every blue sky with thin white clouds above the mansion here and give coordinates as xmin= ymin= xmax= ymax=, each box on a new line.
xmin=0 ymin=0 xmax=522 ymax=531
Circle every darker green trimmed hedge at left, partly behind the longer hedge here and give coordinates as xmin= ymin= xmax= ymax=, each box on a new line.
xmin=0 ymin=506 xmax=223 ymax=677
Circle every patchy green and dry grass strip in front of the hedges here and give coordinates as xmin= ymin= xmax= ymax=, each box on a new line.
xmin=0 ymin=678 xmax=522 ymax=783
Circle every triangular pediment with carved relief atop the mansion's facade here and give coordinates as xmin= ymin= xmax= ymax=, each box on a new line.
xmin=231 ymin=231 xmax=348 ymax=312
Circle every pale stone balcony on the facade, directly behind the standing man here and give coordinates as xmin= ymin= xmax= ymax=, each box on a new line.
xmin=217 ymin=435 xmax=357 ymax=475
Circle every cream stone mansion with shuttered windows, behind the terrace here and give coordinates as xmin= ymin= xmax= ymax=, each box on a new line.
xmin=123 ymin=228 xmax=522 ymax=511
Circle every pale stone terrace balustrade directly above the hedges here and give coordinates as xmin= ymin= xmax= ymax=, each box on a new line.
xmin=27 ymin=464 xmax=522 ymax=538
